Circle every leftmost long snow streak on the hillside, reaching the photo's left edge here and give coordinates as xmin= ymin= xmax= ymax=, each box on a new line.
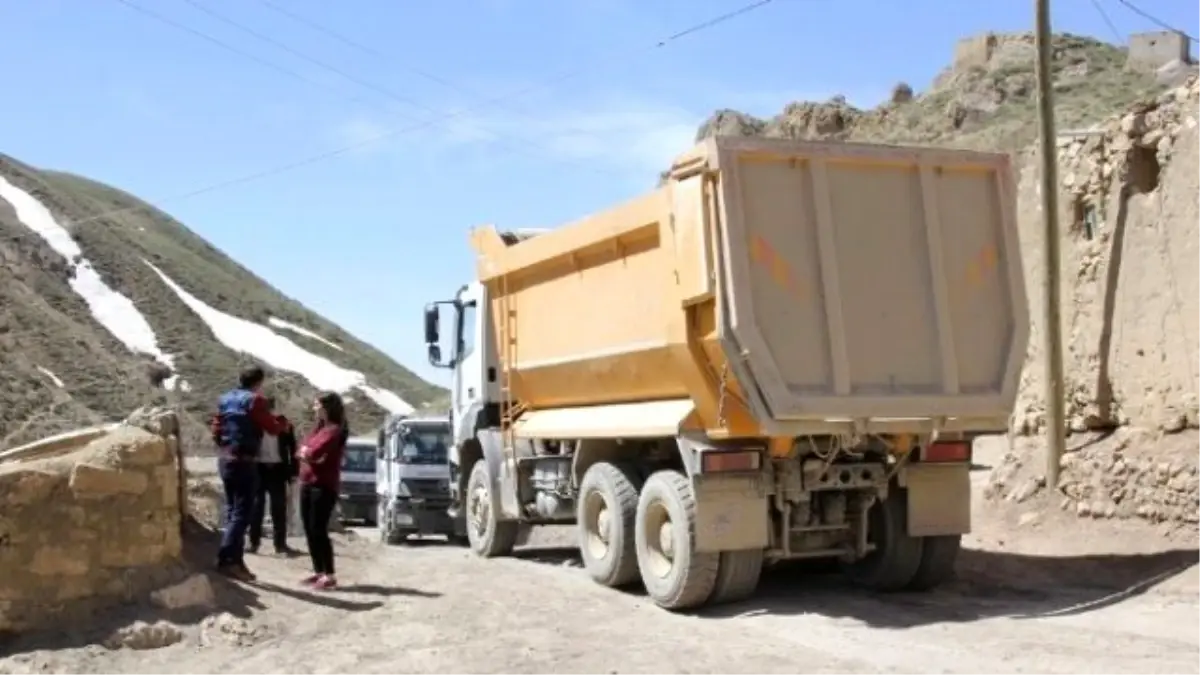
xmin=0 ymin=177 xmax=178 ymax=389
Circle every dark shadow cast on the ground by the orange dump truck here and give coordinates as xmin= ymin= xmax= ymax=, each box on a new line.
xmin=514 ymin=546 xmax=1200 ymax=628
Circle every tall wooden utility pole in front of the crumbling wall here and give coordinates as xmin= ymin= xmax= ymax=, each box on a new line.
xmin=1034 ymin=0 xmax=1067 ymax=489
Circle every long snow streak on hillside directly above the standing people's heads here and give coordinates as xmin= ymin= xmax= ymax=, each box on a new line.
xmin=142 ymin=259 xmax=413 ymax=414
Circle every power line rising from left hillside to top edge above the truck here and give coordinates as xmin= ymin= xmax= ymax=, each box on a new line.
xmin=63 ymin=0 xmax=774 ymax=225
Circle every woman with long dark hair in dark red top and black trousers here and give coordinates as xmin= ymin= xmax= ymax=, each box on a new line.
xmin=296 ymin=392 xmax=350 ymax=590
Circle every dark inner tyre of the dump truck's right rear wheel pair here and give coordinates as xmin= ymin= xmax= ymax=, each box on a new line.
xmin=847 ymin=485 xmax=923 ymax=592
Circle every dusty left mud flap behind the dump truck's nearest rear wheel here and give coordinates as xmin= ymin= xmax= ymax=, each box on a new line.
xmin=691 ymin=473 xmax=769 ymax=552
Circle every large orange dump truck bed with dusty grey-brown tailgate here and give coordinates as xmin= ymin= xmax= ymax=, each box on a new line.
xmin=476 ymin=133 xmax=1028 ymax=429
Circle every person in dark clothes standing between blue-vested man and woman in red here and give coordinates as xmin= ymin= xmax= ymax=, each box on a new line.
xmin=250 ymin=396 xmax=299 ymax=556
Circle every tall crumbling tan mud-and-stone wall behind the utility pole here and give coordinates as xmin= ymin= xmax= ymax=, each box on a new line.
xmin=1014 ymin=78 xmax=1200 ymax=434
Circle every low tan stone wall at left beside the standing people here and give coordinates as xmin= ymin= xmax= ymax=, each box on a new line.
xmin=0 ymin=412 xmax=185 ymax=633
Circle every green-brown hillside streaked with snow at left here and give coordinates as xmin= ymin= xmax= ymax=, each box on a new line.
xmin=0 ymin=155 xmax=442 ymax=450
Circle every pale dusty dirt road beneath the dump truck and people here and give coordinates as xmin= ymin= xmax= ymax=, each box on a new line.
xmin=0 ymin=439 xmax=1200 ymax=675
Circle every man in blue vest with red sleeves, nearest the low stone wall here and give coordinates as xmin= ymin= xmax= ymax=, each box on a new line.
xmin=212 ymin=365 xmax=287 ymax=581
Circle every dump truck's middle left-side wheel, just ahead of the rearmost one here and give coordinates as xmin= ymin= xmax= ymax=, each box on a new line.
xmin=575 ymin=461 xmax=637 ymax=589
